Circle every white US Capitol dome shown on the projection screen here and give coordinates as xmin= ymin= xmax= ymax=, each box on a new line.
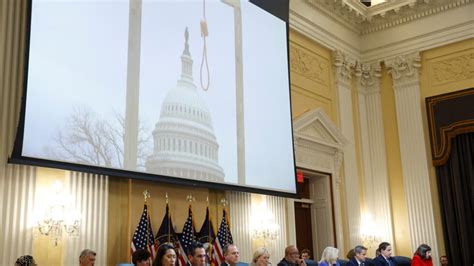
xmin=146 ymin=28 xmax=224 ymax=182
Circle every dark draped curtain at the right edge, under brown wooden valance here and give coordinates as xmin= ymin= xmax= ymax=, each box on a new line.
xmin=436 ymin=133 xmax=474 ymax=265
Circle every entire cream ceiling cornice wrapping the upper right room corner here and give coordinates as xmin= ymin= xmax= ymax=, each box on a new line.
xmin=290 ymin=0 xmax=474 ymax=62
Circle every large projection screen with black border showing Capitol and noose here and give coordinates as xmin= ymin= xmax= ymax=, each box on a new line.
xmin=9 ymin=0 xmax=296 ymax=196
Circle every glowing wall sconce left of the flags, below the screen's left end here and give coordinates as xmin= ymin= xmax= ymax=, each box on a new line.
xmin=35 ymin=181 xmax=81 ymax=246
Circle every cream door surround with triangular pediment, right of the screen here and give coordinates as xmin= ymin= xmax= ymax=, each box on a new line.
xmin=287 ymin=108 xmax=348 ymax=254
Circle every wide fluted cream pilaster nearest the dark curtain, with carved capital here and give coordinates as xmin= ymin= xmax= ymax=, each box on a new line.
xmin=385 ymin=53 xmax=439 ymax=257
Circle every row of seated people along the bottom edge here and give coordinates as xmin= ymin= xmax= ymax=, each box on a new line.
xmin=15 ymin=242 xmax=449 ymax=266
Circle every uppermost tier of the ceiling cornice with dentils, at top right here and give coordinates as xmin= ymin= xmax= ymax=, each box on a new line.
xmin=306 ymin=0 xmax=472 ymax=35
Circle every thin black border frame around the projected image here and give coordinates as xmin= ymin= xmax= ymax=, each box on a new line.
xmin=8 ymin=0 xmax=299 ymax=198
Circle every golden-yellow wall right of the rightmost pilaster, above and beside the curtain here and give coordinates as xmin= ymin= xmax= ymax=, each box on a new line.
xmin=420 ymin=38 xmax=474 ymax=255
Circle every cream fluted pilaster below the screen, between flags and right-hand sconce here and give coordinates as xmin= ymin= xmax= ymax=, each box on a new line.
xmin=226 ymin=191 xmax=253 ymax=263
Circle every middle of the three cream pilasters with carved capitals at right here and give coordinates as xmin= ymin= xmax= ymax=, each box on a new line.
xmin=355 ymin=63 xmax=393 ymax=247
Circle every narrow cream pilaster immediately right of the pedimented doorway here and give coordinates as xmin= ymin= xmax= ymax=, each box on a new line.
xmin=334 ymin=51 xmax=360 ymax=246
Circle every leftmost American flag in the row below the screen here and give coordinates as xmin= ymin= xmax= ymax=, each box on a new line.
xmin=131 ymin=204 xmax=156 ymax=259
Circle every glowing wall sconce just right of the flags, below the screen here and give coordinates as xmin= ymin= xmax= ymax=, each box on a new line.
xmin=250 ymin=202 xmax=280 ymax=245
